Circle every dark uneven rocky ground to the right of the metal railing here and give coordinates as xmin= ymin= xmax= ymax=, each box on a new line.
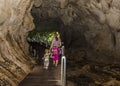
xmin=67 ymin=59 xmax=120 ymax=86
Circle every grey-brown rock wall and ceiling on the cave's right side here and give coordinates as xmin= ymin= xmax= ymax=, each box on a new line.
xmin=32 ymin=0 xmax=120 ymax=63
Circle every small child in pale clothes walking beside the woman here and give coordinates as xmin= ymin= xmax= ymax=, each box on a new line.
xmin=42 ymin=49 xmax=50 ymax=70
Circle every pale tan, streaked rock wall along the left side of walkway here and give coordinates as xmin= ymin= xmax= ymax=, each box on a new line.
xmin=0 ymin=0 xmax=34 ymax=86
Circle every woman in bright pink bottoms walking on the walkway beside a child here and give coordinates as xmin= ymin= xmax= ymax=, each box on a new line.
xmin=50 ymin=33 xmax=61 ymax=66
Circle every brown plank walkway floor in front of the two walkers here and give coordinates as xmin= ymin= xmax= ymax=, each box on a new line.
xmin=18 ymin=65 xmax=60 ymax=86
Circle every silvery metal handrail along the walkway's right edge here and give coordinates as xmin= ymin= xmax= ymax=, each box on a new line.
xmin=61 ymin=46 xmax=66 ymax=86
